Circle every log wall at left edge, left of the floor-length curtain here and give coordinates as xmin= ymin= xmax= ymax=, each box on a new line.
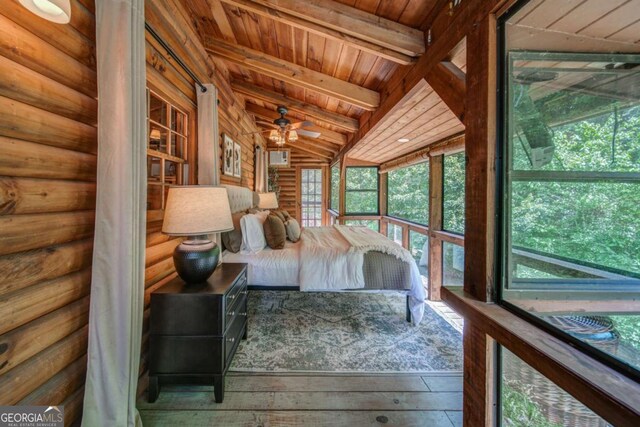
xmin=0 ymin=0 xmax=97 ymax=424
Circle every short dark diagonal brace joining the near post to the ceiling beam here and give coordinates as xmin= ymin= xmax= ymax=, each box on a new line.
xmin=426 ymin=61 xmax=466 ymax=121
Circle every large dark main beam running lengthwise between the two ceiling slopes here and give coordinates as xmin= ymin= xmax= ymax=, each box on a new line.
xmin=333 ymin=0 xmax=508 ymax=165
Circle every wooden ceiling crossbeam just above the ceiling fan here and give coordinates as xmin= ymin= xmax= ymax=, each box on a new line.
xmin=231 ymin=81 xmax=359 ymax=132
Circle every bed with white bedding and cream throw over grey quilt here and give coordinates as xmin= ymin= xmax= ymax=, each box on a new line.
xmin=222 ymin=185 xmax=425 ymax=325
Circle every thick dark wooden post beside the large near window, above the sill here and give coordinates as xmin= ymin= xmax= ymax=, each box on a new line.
xmin=464 ymin=15 xmax=497 ymax=301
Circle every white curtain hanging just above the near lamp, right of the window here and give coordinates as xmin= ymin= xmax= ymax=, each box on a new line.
xmin=196 ymin=84 xmax=220 ymax=185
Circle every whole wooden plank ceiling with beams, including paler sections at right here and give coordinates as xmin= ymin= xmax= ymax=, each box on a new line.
xmin=181 ymin=0 xmax=640 ymax=164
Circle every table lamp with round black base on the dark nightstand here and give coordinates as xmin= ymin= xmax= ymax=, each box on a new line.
xmin=162 ymin=185 xmax=233 ymax=283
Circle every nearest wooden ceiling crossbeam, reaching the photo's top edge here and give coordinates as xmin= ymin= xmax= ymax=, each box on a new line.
xmin=222 ymin=0 xmax=416 ymax=65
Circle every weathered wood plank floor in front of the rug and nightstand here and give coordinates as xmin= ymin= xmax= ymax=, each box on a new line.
xmin=138 ymin=373 xmax=462 ymax=427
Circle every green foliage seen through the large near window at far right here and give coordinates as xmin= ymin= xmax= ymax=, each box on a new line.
xmin=511 ymin=107 xmax=640 ymax=273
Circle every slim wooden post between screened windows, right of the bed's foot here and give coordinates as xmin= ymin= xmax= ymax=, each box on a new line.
xmin=429 ymin=155 xmax=444 ymax=301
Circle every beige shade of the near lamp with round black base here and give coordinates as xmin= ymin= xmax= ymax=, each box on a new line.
xmin=162 ymin=185 xmax=233 ymax=236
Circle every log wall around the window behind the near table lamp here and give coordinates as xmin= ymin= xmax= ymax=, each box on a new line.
xmin=138 ymin=0 xmax=264 ymax=394
